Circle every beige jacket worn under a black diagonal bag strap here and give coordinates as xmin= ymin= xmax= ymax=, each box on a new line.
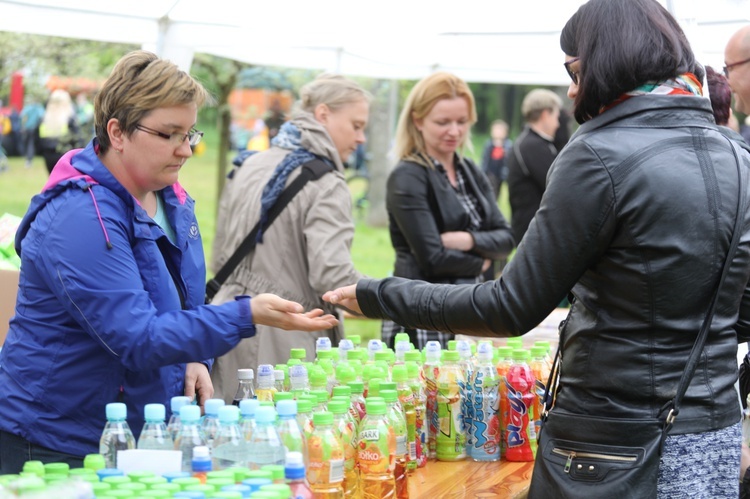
xmin=211 ymin=113 xmax=361 ymax=403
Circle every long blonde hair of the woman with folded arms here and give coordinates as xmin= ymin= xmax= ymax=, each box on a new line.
xmin=395 ymin=72 xmax=477 ymax=168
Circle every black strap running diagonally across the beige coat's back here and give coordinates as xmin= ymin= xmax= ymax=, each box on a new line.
xmin=206 ymin=158 xmax=333 ymax=303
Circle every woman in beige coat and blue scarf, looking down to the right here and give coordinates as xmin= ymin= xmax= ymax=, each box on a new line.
xmin=211 ymin=75 xmax=370 ymax=402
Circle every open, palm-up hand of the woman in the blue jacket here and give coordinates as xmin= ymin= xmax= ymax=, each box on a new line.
xmin=250 ymin=293 xmax=339 ymax=331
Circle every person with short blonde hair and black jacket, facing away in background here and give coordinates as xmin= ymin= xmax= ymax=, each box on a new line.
xmin=508 ymin=88 xmax=562 ymax=244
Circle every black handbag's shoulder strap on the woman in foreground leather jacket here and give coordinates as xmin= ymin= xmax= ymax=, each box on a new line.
xmin=541 ymin=137 xmax=745 ymax=438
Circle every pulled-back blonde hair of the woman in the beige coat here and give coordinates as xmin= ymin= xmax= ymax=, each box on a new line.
xmin=298 ymin=73 xmax=372 ymax=113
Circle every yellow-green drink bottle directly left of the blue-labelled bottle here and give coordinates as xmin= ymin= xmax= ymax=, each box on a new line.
xmin=436 ymin=350 xmax=466 ymax=461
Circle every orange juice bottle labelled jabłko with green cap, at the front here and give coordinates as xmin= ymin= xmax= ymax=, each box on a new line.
xmin=357 ymin=397 xmax=396 ymax=499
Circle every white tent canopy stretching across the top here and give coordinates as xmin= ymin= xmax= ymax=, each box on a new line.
xmin=0 ymin=0 xmax=750 ymax=85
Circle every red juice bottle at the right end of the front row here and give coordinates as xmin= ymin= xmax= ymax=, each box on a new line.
xmin=505 ymin=349 xmax=536 ymax=461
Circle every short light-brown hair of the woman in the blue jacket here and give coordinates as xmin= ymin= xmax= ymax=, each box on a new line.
xmin=94 ymin=50 xmax=212 ymax=153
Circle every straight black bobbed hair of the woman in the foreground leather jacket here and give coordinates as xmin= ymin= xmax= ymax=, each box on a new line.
xmin=560 ymin=0 xmax=703 ymax=123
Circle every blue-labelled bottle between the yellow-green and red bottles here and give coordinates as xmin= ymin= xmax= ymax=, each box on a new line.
xmin=468 ymin=343 xmax=500 ymax=461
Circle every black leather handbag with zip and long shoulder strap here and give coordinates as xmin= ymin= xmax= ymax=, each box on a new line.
xmin=528 ymin=141 xmax=745 ymax=499
